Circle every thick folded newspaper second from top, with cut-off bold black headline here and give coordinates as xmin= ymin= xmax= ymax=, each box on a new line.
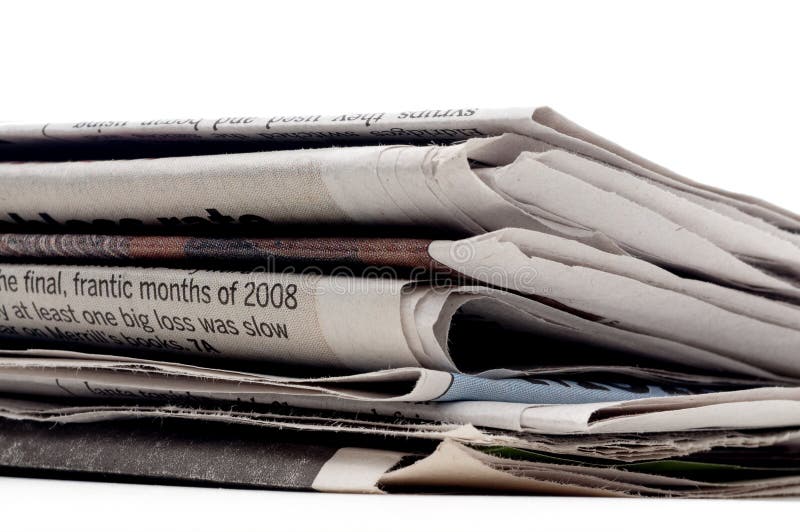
xmin=0 ymin=134 xmax=800 ymax=299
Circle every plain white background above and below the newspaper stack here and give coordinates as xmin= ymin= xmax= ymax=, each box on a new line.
xmin=0 ymin=0 xmax=800 ymax=531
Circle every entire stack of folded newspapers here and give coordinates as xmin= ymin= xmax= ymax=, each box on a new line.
xmin=0 ymin=108 xmax=800 ymax=497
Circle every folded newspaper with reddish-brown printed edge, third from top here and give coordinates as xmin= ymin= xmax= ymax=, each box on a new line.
xmin=0 ymin=229 xmax=800 ymax=329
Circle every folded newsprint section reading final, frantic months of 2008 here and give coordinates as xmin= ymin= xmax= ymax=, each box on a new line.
xmin=0 ymin=264 xmax=692 ymax=371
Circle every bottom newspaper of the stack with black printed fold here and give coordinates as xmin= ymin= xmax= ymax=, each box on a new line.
xmin=0 ymin=404 xmax=800 ymax=497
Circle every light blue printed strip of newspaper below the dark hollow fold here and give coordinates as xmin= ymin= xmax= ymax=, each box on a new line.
xmin=436 ymin=373 xmax=714 ymax=404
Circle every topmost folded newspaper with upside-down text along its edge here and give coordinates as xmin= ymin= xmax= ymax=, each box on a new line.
xmin=0 ymin=107 xmax=800 ymax=235
